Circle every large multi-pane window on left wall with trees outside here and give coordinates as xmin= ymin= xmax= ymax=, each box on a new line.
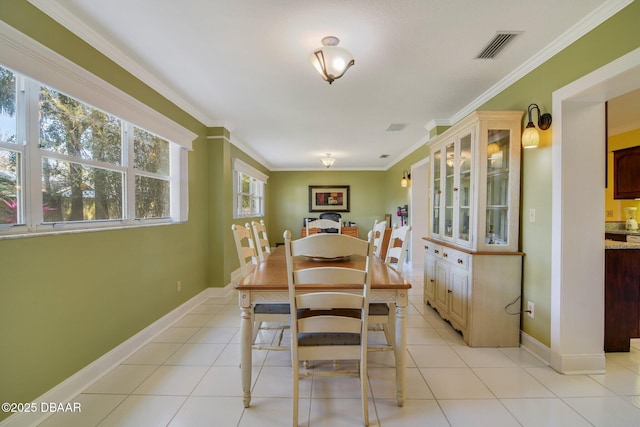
xmin=0 ymin=66 xmax=186 ymax=233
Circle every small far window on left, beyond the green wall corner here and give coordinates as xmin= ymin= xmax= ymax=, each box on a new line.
xmin=234 ymin=159 xmax=268 ymax=218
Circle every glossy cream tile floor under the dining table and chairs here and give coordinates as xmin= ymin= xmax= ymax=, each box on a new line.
xmin=41 ymin=271 xmax=640 ymax=427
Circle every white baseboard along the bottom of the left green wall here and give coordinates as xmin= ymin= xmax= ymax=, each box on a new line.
xmin=0 ymin=284 xmax=234 ymax=427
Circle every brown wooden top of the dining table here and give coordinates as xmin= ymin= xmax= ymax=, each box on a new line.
xmin=235 ymin=246 xmax=411 ymax=290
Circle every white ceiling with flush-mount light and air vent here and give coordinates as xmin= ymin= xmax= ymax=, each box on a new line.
xmin=30 ymin=0 xmax=628 ymax=170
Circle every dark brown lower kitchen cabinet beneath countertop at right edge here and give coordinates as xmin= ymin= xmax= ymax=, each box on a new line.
xmin=604 ymin=249 xmax=640 ymax=351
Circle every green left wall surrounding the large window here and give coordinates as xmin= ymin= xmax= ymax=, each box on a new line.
xmin=0 ymin=0 xmax=215 ymax=420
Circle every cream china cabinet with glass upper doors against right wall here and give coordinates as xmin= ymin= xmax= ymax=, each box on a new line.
xmin=424 ymin=111 xmax=523 ymax=346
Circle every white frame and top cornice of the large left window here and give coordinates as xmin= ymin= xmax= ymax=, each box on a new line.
xmin=0 ymin=23 xmax=197 ymax=238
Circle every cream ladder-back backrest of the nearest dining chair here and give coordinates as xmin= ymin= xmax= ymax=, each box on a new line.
xmin=284 ymin=230 xmax=373 ymax=352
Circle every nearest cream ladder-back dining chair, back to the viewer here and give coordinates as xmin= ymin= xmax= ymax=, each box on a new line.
xmin=284 ymin=230 xmax=373 ymax=426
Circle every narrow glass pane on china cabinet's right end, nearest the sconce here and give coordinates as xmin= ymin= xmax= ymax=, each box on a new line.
xmin=485 ymin=129 xmax=511 ymax=245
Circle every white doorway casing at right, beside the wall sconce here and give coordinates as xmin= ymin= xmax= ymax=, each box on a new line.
xmin=550 ymin=48 xmax=640 ymax=374
